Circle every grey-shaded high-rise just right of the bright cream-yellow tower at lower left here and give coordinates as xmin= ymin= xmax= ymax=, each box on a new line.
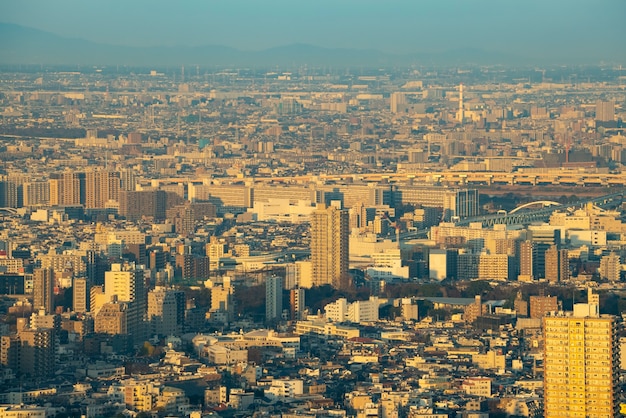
xmin=148 ymin=286 xmax=185 ymax=336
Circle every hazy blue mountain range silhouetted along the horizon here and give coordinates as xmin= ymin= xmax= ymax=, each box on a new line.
xmin=0 ymin=23 xmax=529 ymax=68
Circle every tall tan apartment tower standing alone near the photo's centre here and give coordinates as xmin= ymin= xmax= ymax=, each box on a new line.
xmin=311 ymin=204 xmax=349 ymax=288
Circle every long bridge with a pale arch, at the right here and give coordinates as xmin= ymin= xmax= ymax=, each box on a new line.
xmin=455 ymin=192 xmax=624 ymax=227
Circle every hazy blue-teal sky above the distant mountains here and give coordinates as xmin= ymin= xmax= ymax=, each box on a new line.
xmin=0 ymin=0 xmax=626 ymax=61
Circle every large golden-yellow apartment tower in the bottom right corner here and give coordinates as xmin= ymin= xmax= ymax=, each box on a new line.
xmin=543 ymin=303 xmax=619 ymax=418
